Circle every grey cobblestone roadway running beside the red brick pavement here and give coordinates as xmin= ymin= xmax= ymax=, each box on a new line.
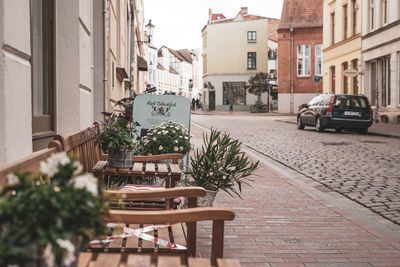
xmin=192 ymin=114 xmax=400 ymax=224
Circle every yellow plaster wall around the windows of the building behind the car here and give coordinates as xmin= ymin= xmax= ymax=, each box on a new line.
xmin=322 ymin=0 xmax=362 ymax=94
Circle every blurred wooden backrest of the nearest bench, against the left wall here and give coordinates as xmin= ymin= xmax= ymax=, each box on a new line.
xmin=0 ymin=140 xmax=62 ymax=188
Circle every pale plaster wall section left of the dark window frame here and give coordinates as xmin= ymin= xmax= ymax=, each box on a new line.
xmin=0 ymin=0 xmax=32 ymax=166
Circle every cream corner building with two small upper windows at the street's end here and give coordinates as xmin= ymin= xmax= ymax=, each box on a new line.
xmin=202 ymin=7 xmax=276 ymax=110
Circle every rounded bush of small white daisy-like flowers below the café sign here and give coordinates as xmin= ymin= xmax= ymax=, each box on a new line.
xmin=137 ymin=121 xmax=190 ymax=155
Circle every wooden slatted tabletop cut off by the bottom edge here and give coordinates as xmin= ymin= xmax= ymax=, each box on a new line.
xmin=78 ymin=252 xmax=240 ymax=267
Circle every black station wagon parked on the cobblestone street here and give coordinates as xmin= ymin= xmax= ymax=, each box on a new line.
xmin=297 ymin=94 xmax=373 ymax=133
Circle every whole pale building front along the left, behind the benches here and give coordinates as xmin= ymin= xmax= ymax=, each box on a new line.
xmin=0 ymin=0 xmax=143 ymax=165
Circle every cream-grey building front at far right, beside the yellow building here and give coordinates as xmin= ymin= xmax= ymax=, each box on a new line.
xmin=362 ymin=0 xmax=400 ymax=123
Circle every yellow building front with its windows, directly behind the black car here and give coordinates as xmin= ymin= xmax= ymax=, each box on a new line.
xmin=322 ymin=0 xmax=363 ymax=95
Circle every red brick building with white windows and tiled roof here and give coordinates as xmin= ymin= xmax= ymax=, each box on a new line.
xmin=278 ymin=0 xmax=323 ymax=113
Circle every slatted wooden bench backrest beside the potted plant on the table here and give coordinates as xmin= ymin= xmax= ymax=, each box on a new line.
xmin=54 ymin=123 xmax=101 ymax=172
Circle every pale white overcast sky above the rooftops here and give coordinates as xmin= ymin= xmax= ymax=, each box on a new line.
xmin=143 ymin=0 xmax=283 ymax=50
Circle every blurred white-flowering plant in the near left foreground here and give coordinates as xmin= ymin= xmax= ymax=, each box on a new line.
xmin=0 ymin=152 xmax=107 ymax=266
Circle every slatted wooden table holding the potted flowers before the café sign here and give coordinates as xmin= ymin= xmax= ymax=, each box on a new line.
xmin=92 ymin=160 xmax=182 ymax=188
